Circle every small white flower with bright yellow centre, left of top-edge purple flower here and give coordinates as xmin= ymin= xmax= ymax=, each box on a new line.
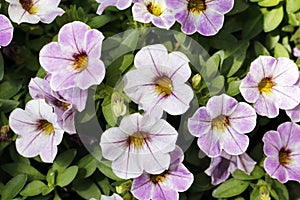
xmin=132 ymin=0 xmax=175 ymax=29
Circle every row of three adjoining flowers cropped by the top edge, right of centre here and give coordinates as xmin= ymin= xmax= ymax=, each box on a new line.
xmin=97 ymin=0 xmax=234 ymax=36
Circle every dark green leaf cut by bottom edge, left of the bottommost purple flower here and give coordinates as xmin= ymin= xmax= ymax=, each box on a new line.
xmin=73 ymin=179 xmax=101 ymax=199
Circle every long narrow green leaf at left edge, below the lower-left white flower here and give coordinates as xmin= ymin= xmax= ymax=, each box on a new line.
xmin=1 ymin=162 xmax=45 ymax=180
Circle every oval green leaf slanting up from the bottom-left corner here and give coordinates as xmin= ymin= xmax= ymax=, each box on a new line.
xmin=1 ymin=174 xmax=27 ymax=200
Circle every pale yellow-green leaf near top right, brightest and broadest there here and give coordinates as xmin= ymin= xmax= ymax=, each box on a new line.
xmin=261 ymin=6 xmax=284 ymax=32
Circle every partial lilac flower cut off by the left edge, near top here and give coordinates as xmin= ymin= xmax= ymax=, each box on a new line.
xmin=0 ymin=14 xmax=14 ymax=48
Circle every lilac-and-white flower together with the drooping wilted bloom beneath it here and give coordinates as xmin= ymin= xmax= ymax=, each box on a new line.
xmin=188 ymin=94 xmax=256 ymax=184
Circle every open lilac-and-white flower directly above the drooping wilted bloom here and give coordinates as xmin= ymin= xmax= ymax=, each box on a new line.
xmin=188 ymin=94 xmax=257 ymax=157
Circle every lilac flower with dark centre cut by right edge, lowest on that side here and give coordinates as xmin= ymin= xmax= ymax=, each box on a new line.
xmin=263 ymin=122 xmax=300 ymax=183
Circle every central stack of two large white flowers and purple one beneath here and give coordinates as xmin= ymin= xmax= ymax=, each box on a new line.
xmin=100 ymin=44 xmax=193 ymax=200
